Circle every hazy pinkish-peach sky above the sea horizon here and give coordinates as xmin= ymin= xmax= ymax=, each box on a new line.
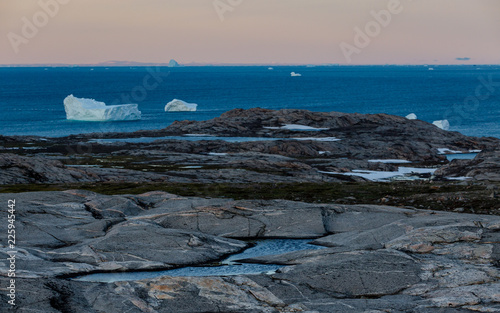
xmin=0 ymin=0 xmax=500 ymax=64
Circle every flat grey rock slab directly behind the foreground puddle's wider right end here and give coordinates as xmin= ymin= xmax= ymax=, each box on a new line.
xmin=145 ymin=200 xmax=326 ymax=238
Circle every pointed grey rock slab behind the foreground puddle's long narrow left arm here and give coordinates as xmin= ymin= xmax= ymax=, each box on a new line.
xmin=45 ymin=222 xmax=247 ymax=271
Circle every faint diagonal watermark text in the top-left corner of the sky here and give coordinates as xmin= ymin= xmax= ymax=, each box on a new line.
xmin=7 ymin=0 xmax=71 ymax=54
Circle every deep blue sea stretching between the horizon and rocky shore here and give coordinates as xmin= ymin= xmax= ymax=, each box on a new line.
xmin=0 ymin=65 xmax=500 ymax=137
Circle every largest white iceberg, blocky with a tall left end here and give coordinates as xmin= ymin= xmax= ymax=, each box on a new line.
xmin=64 ymin=95 xmax=141 ymax=122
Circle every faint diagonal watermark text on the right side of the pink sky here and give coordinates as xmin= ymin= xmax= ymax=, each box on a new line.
xmin=340 ymin=0 xmax=411 ymax=64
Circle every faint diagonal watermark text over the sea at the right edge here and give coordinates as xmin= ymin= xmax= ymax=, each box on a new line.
xmin=443 ymin=74 xmax=500 ymax=125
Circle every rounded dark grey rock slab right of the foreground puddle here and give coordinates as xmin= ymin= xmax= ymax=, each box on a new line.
xmin=273 ymin=250 xmax=420 ymax=297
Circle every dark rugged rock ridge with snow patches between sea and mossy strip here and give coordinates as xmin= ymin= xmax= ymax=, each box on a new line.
xmin=0 ymin=109 xmax=500 ymax=185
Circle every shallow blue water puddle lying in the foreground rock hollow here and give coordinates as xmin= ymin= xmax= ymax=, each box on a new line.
xmin=74 ymin=239 xmax=324 ymax=283
